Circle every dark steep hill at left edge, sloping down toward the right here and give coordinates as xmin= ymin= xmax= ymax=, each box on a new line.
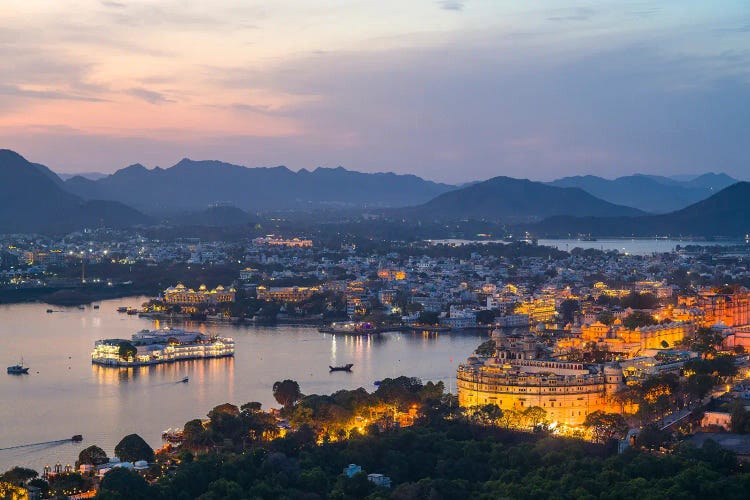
xmin=0 ymin=149 xmax=148 ymax=233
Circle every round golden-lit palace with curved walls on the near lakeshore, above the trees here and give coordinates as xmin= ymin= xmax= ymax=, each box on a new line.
xmin=456 ymin=333 xmax=624 ymax=426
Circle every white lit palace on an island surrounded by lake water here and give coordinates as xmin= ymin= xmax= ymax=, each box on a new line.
xmin=91 ymin=328 xmax=234 ymax=366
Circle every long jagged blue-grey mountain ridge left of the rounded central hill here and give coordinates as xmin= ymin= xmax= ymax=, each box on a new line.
xmin=65 ymin=159 xmax=453 ymax=215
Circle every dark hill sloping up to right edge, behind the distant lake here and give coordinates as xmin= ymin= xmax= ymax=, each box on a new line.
xmin=531 ymin=182 xmax=750 ymax=238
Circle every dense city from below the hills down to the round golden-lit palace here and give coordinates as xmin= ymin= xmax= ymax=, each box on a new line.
xmin=0 ymin=232 xmax=750 ymax=427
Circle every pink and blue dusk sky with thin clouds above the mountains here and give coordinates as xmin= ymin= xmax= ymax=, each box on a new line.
xmin=0 ymin=0 xmax=750 ymax=183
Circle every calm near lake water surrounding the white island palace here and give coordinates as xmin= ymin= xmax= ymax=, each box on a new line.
xmin=0 ymin=298 xmax=486 ymax=472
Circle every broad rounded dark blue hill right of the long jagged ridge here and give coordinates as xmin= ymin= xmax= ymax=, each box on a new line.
xmin=403 ymin=177 xmax=643 ymax=221
